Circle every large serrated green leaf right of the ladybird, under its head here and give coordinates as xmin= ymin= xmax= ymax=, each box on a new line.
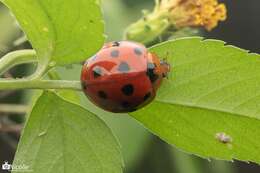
xmin=131 ymin=38 xmax=260 ymax=163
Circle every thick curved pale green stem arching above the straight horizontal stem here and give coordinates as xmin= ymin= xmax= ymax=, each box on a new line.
xmin=0 ymin=49 xmax=37 ymax=75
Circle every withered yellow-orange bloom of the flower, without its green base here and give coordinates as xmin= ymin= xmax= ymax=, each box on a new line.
xmin=155 ymin=0 xmax=227 ymax=31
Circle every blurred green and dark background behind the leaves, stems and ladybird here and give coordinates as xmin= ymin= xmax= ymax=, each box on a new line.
xmin=0 ymin=0 xmax=260 ymax=173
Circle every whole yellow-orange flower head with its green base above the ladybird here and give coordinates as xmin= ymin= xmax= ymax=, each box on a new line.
xmin=124 ymin=0 xmax=227 ymax=45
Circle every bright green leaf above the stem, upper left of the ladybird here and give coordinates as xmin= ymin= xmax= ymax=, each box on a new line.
xmin=0 ymin=0 xmax=104 ymax=65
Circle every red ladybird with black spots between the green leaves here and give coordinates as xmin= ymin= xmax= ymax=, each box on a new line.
xmin=81 ymin=41 xmax=170 ymax=113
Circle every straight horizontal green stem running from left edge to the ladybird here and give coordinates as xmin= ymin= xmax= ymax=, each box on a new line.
xmin=0 ymin=79 xmax=81 ymax=90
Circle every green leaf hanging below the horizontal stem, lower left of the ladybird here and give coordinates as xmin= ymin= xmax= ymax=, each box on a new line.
xmin=14 ymin=92 xmax=122 ymax=173
